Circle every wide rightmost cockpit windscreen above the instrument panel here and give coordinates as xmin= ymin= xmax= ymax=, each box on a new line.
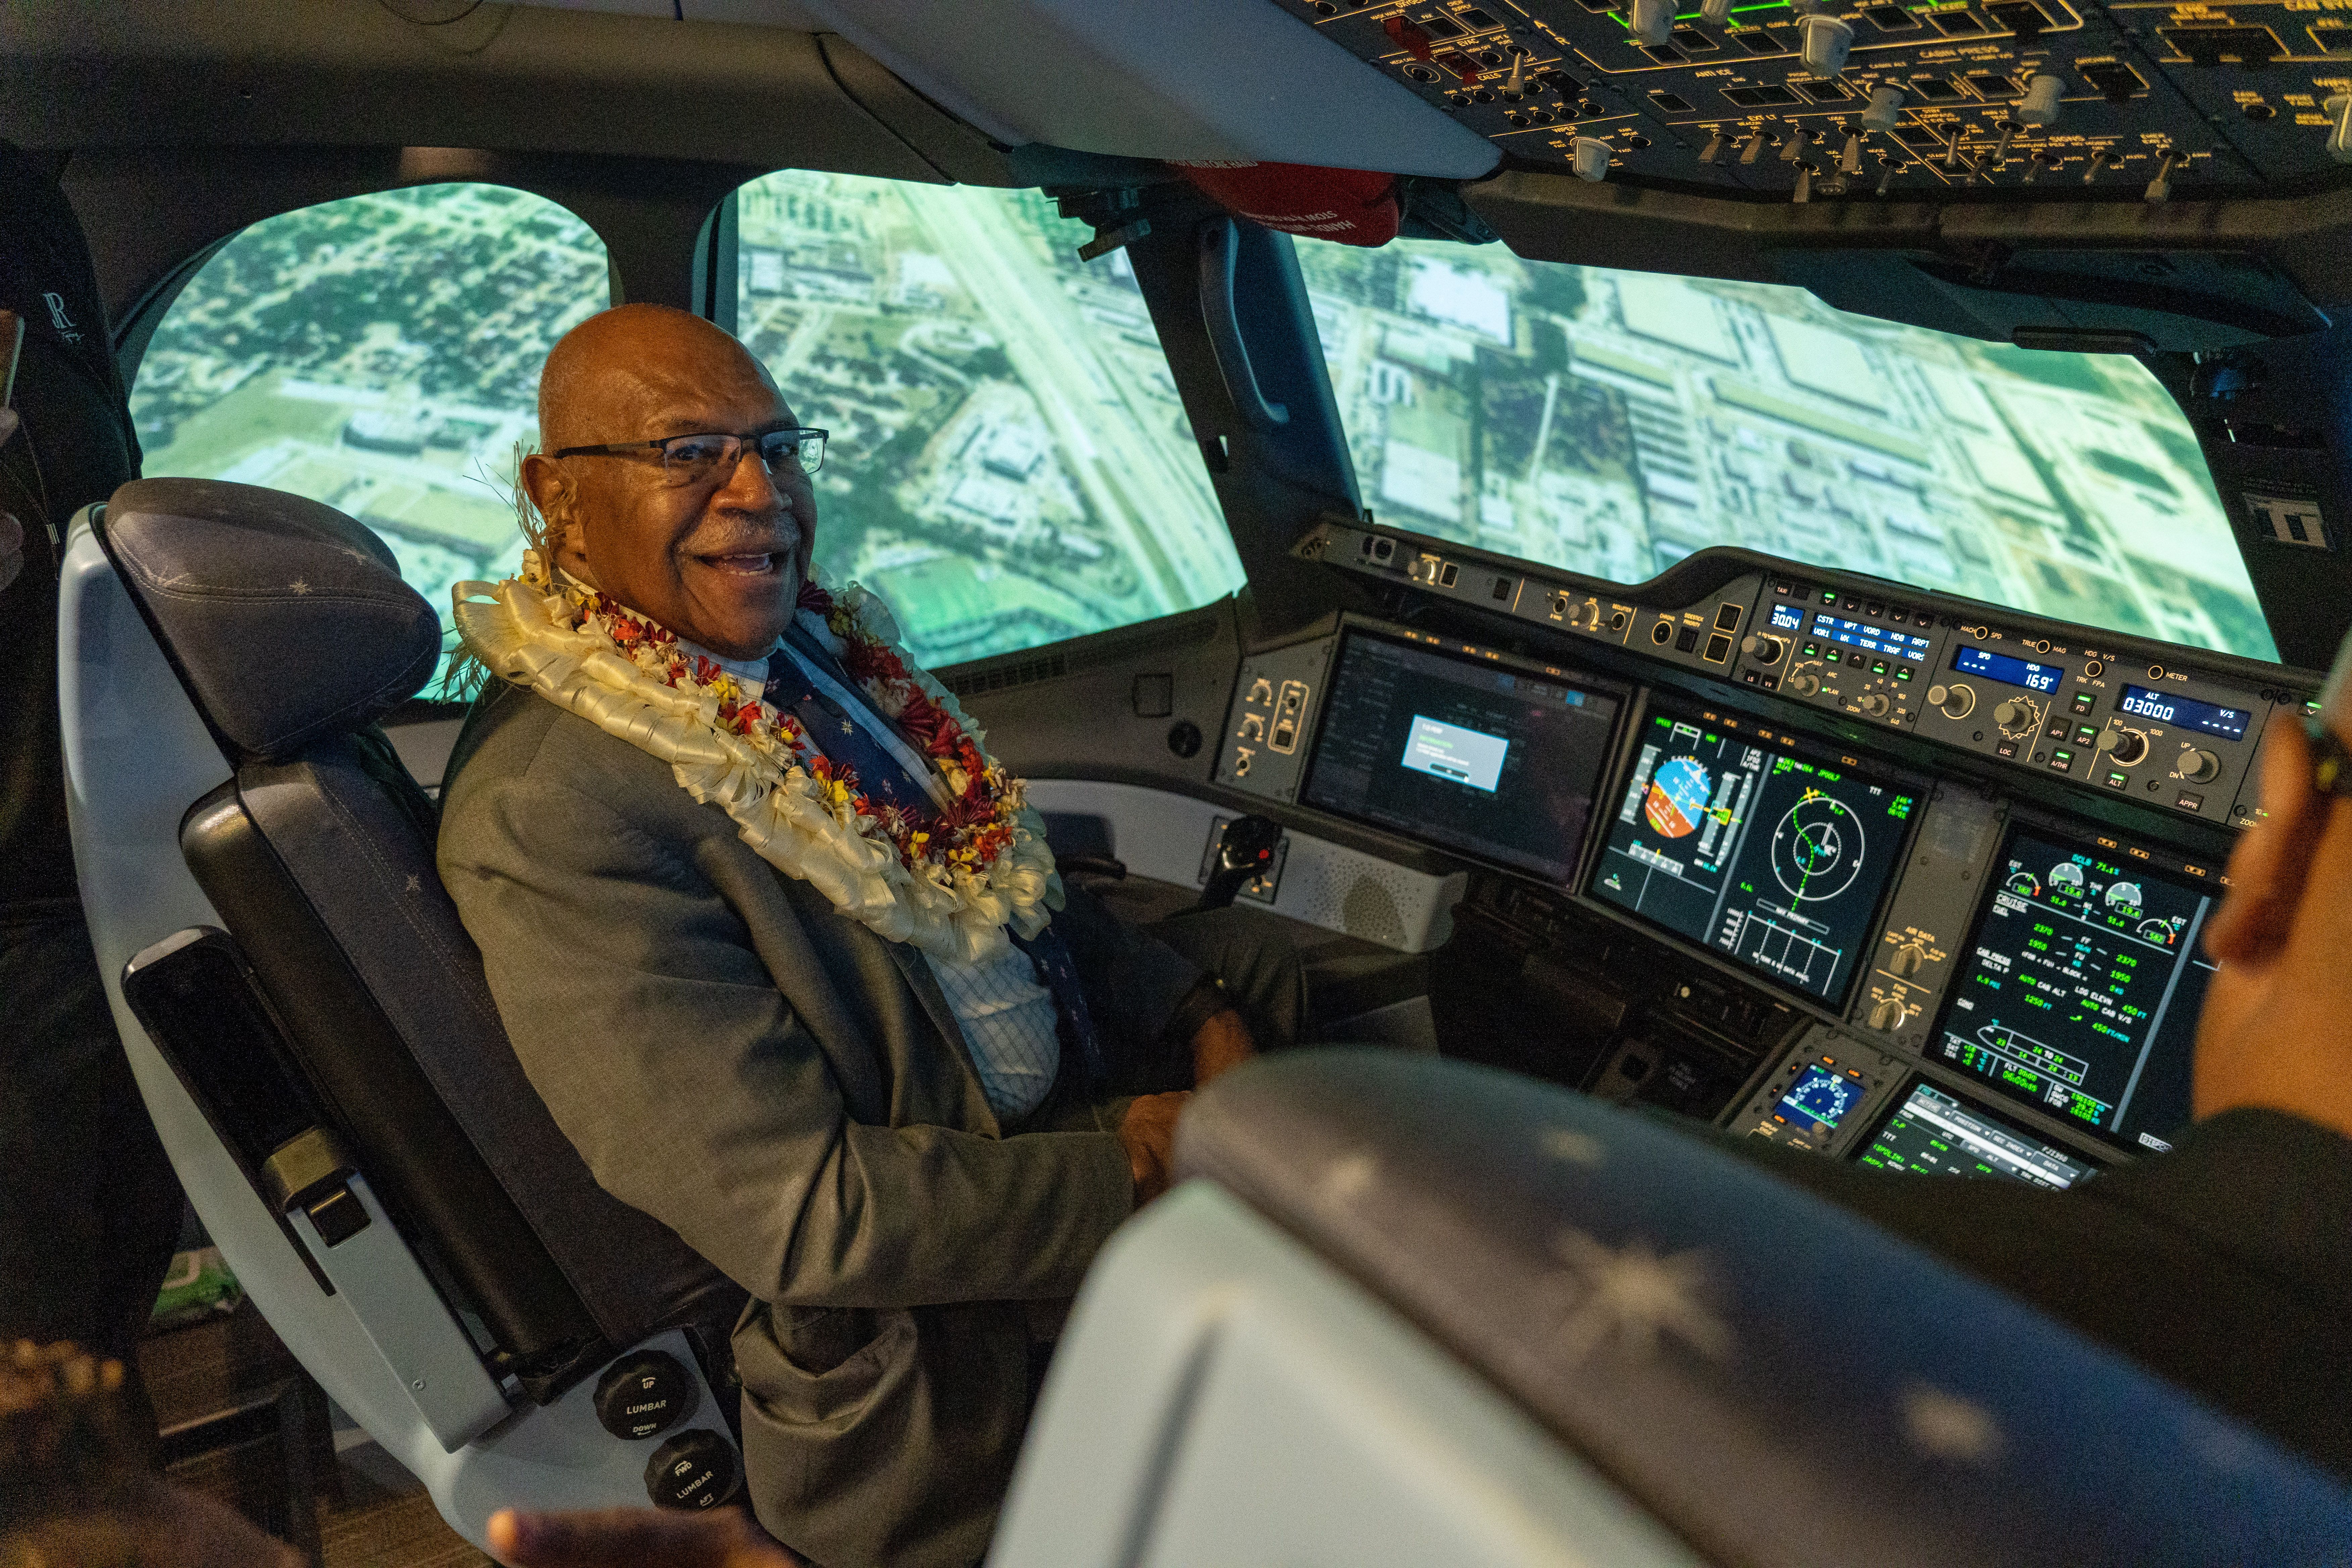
xmin=1298 ymin=240 xmax=2277 ymax=658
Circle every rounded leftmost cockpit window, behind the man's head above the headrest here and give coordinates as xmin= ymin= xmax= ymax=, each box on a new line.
xmin=132 ymin=183 xmax=611 ymax=677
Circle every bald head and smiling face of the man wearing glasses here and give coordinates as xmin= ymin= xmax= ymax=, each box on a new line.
xmin=522 ymin=306 xmax=816 ymax=658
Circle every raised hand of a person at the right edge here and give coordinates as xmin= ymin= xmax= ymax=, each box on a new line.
xmin=2194 ymin=677 xmax=2352 ymax=1138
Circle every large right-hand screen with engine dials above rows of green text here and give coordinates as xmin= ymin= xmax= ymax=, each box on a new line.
xmin=1929 ymin=828 xmax=2213 ymax=1149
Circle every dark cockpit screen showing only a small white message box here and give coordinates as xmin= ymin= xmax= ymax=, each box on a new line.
xmin=1305 ymin=630 xmax=1621 ymax=882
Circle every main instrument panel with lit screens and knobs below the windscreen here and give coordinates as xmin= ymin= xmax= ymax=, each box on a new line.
xmin=1218 ymin=524 xmax=2317 ymax=1187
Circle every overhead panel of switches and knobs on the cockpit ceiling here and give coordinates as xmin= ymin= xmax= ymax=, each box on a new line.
xmin=1268 ymin=0 xmax=2352 ymax=202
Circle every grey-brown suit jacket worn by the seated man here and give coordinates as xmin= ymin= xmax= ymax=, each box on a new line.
xmin=440 ymin=684 xmax=1199 ymax=1568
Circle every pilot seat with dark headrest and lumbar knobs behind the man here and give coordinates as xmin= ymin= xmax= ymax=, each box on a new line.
xmin=59 ymin=480 xmax=746 ymax=1542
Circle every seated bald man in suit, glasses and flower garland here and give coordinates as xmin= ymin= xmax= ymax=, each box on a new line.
xmin=440 ymin=306 xmax=1303 ymax=1568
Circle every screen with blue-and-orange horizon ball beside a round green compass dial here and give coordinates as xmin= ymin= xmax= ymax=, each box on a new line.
xmin=1590 ymin=707 xmax=1917 ymax=1006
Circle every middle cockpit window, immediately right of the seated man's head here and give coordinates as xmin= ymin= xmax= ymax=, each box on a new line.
xmin=736 ymin=169 xmax=1242 ymax=665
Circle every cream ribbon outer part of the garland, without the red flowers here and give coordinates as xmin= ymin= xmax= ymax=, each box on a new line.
xmin=452 ymin=564 xmax=1063 ymax=964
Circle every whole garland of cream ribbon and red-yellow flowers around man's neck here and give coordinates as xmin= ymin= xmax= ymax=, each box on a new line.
xmin=454 ymin=552 xmax=1061 ymax=964
